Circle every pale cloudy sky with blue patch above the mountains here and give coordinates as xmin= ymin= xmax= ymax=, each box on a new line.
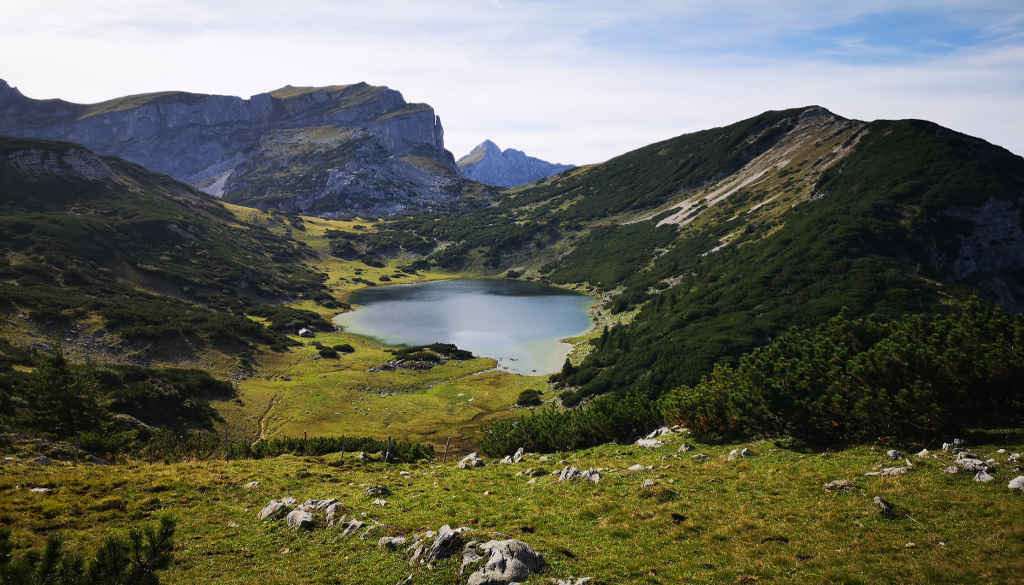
xmin=0 ymin=0 xmax=1024 ymax=164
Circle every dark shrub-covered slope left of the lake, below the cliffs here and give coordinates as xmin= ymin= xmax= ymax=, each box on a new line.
xmin=0 ymin=138 xmax=334 ymax=362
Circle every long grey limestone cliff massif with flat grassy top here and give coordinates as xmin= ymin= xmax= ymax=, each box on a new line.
xmin=0 ymin=80 xmax=463 ymax=215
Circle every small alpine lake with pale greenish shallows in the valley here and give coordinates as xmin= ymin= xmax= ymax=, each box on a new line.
xmin=334 ymin=279 xmax=594 ymax=375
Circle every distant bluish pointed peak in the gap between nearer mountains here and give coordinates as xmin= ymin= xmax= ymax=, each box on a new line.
xmin=457 ymin=140 xmax=575 ymax=186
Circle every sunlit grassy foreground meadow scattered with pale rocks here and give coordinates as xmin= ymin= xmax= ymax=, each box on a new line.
xmin=0 ymin=433 xmax=1024 ymax=584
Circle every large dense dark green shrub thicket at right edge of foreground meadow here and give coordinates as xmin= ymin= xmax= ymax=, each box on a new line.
xmin=660 ymin=299 xmax=1024 ymax=445
